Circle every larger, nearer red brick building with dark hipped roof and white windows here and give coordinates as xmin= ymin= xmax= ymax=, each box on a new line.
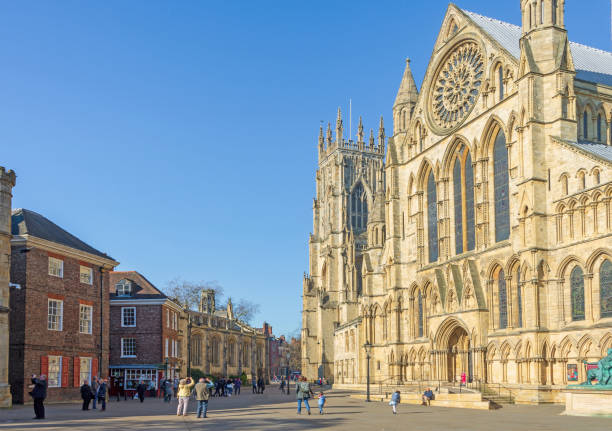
xmin=9 ymin=209 xmax=118 ymax=403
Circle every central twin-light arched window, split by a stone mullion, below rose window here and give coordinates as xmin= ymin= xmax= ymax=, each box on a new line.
xmin=453 ymin=147 xmax=476 ymax=254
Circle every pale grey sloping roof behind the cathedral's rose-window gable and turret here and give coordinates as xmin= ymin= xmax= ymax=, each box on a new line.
xmin=462 ymin=10 xmax=612 ymax=86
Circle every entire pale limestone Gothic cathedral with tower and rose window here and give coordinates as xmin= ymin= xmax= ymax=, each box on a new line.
xmin=302 ymin=0 xmax=612 ymax=402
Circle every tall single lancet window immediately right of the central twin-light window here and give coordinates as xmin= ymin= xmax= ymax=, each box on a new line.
xmin=493 ymin=130 xmax=510 ymax=242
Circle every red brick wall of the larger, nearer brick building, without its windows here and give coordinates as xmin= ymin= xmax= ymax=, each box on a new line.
xmin=9 ymin=247 xmax=109 ymax=403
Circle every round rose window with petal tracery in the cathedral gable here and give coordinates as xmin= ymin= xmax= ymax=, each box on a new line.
xmin=430 ymin=41 xmax=484 ymax=132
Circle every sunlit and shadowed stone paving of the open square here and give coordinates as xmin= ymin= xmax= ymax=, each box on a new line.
xmin=0 ymin=386 xmax=612 ymax=431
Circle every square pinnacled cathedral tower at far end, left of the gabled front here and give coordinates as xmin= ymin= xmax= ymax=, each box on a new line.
xmin=302 ymin=109 xmax=385 ymax=379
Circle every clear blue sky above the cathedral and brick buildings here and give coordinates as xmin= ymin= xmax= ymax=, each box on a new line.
xmin=0 ymin=0 xmax=610 ymax=334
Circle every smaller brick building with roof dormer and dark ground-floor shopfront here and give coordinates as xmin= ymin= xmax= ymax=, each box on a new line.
xmin=109 ymin=271 xmax=182 ymax=395
